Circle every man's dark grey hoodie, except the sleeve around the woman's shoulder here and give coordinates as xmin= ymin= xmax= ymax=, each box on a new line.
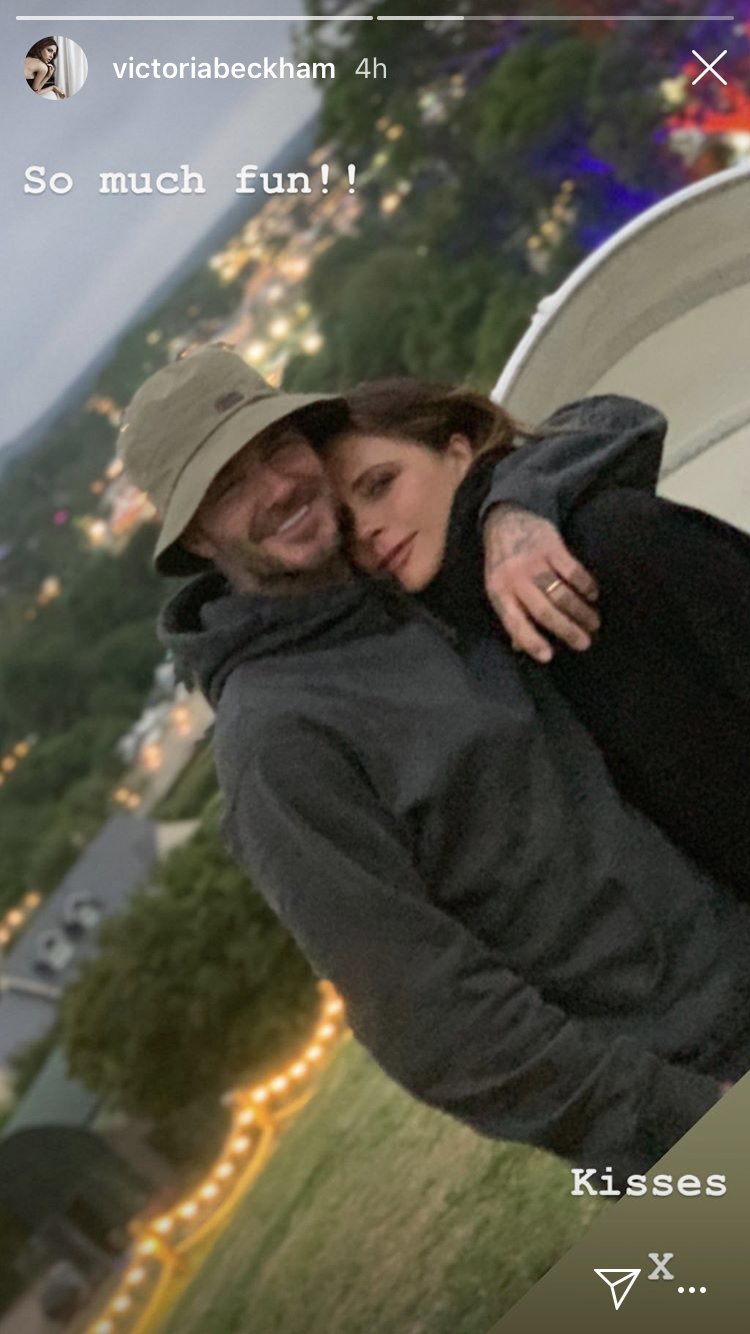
xmin=160 ymin=392 xmax=750 ymax=1174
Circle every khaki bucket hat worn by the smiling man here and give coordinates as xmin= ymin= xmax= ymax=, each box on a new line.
xmin=117 ymin=344 xmax=347 ymax=575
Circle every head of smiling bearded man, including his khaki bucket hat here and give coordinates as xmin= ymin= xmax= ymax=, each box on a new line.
xmin=120 ymin=344 xmax=351 ymax=594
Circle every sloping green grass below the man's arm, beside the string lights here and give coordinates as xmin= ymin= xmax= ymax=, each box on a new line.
xmin=159 ymin=1041 xmax=602 ymax=1334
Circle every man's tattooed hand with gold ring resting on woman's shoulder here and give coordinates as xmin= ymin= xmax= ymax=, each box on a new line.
xmin=484 ymin=504 xmax=601 ymax=663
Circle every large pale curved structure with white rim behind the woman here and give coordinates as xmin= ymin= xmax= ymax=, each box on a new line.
xmin=492 ymin=164 xmax=750 ymax=528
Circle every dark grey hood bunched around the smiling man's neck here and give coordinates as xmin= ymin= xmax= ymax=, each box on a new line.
xmin=156 ymin=571 xmax=415 ymax=708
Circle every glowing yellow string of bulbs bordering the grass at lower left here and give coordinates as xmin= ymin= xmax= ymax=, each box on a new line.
xmin=84 ymin=982 xmax=347 ymax=1334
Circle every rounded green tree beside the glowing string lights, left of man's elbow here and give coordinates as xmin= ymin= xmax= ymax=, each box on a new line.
xmin=61 ymin=819 xmax=316 ymax=1118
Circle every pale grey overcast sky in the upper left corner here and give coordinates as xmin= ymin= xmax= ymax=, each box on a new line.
xmin=0 ymin=0 xmax=318 ymax=447
